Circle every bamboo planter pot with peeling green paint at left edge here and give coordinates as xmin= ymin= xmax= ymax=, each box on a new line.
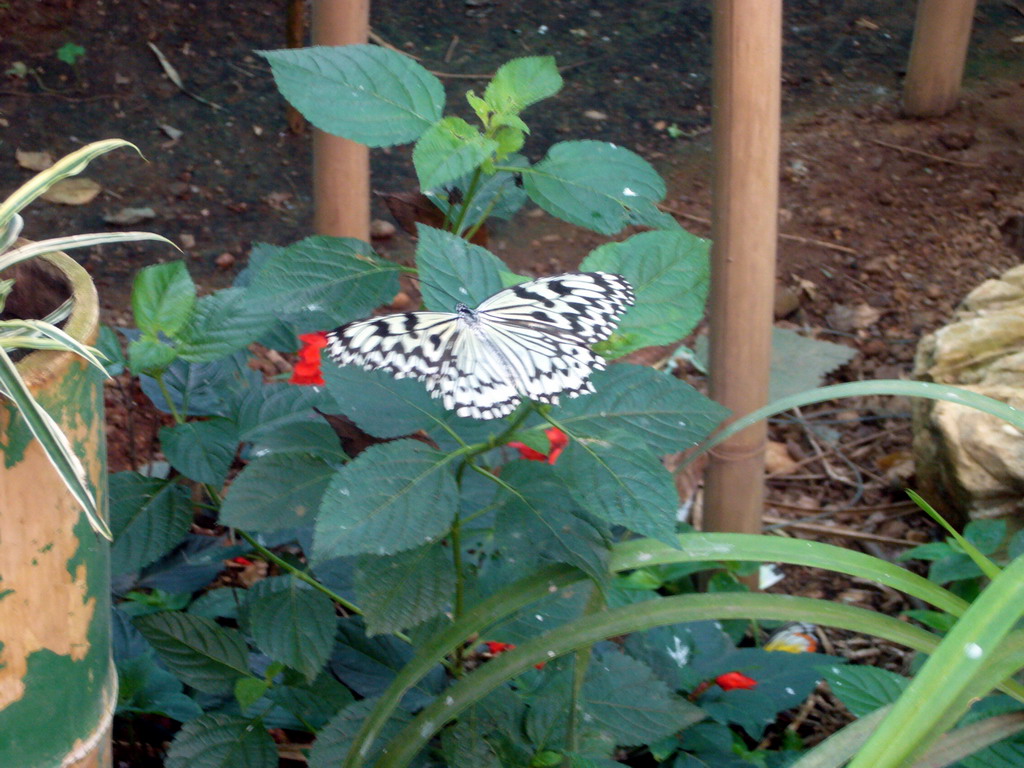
xmin=0 ymin=253 xmax=117 ymax=768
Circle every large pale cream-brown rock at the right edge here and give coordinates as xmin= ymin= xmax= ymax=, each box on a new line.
xmin=913 ymin=266 xmax=1024 ymax=520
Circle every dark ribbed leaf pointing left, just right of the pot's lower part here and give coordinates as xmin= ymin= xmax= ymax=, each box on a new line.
xmin=134 ymin=611 xmax=249 ymax=694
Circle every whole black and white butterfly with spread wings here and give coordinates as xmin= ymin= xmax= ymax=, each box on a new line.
xmin=327 ymin=272 xmax=634 ymax=419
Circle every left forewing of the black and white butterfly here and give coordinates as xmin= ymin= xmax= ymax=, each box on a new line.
xmin=327 ymin=312 xmax=458 ymax=382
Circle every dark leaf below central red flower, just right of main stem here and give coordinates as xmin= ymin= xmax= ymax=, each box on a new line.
xmin=495 ymin=461 xmax=610 ymax=582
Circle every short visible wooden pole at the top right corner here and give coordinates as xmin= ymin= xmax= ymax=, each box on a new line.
xmin=903 ymin=0 xmax=977 ymax=118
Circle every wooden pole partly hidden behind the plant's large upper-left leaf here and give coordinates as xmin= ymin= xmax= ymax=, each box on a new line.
xmin=312 ymin=0 xmax=370 ymax=242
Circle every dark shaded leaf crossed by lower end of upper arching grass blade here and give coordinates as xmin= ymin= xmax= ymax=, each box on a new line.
xmin=331 ymin=618 xmax=445 ymax=710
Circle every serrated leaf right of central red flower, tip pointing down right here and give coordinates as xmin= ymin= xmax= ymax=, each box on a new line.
xmin=556 ymin=440 xmax=679 ymax=546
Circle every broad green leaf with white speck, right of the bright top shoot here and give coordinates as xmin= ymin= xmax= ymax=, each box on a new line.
xmin=523 ymin=141 xmax=665 ymax=234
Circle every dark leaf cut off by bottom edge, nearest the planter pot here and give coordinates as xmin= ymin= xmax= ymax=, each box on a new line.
xmin=165 ymin=713 xmax=278 ymax=768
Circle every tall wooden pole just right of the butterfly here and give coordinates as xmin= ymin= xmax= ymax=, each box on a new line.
xmin=705 ymin=0 xmax=782 ymax=534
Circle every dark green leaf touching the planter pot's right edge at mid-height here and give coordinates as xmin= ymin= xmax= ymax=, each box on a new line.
xmin=110 ymin=472 xmax=193 ymax=575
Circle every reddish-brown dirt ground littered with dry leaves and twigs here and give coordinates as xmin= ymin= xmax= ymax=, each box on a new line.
xmin=6 ymin=0 xmax=1024 ymax=761
